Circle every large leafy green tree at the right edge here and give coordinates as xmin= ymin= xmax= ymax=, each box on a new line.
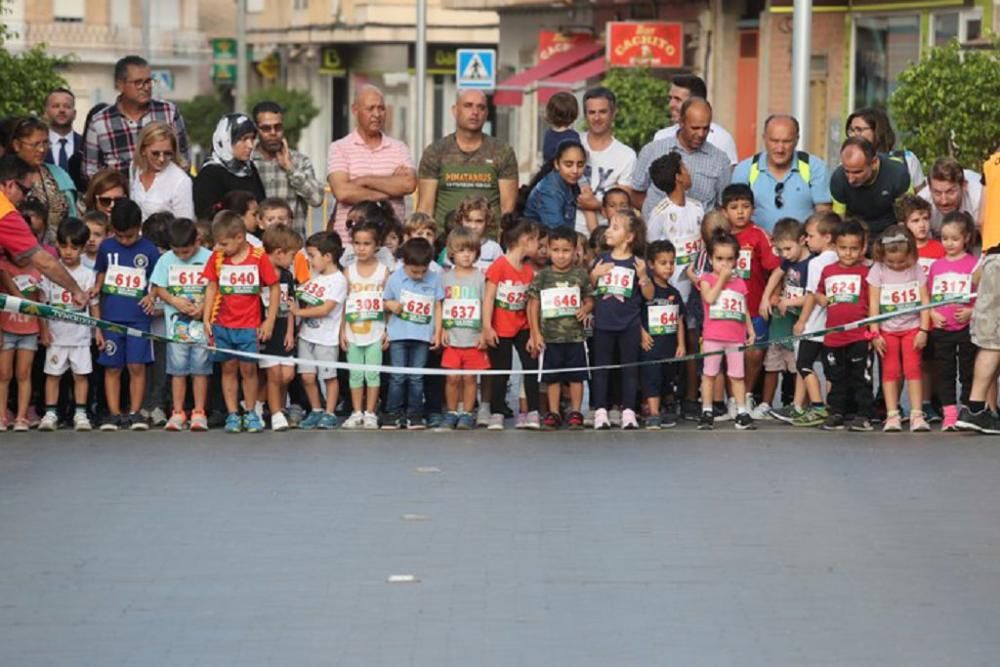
xmin=889 ymin=39 xmax=1000 ymax=171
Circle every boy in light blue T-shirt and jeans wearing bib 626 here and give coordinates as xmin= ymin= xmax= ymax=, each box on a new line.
xmin=382 ymin=237 xmax=444 ymax=430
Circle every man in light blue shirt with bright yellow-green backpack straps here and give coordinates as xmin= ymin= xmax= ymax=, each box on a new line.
xmin=732 ymin=114 xmax=832 ymax=234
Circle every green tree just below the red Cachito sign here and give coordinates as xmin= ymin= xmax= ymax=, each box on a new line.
xmin=601 ymin=67 xmax=670 ymax=151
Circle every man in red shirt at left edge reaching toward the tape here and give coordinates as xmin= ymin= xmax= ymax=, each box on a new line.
xmin=0 ymin=155 xmax=90 ymax=307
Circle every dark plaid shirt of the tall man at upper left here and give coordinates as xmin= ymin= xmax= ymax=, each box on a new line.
xmin=83 ymin=100 xmax=191 ymax=179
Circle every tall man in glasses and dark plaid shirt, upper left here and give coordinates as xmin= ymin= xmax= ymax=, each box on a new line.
xmin=83 ymin=56 xmax=190 ymax=180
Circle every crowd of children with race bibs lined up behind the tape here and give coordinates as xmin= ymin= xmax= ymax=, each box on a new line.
xmin=0 ymin=149 xmax=1000 ymax=433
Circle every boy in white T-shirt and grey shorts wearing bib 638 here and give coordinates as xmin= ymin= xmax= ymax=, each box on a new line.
xmin=291 ymin=232 xmax=347 ymax=430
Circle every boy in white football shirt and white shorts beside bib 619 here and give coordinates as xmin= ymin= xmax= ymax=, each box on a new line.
xmin=36 ymin=218 xmax=100 ymax=431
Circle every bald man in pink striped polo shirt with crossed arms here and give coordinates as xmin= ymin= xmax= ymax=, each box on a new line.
xmin=327 ymin=86 xmax=417 ymax=243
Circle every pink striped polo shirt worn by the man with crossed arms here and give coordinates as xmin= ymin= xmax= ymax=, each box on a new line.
xmin=326 ymin=130 xmax=414 ymax=243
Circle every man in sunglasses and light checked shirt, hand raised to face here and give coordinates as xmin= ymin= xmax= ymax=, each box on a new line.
xmin=252 ymin=101 xmax=325 ymax=236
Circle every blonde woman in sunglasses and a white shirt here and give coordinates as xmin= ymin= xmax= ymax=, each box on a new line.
xmin=129 ymin=122 xmax=194 ymax=220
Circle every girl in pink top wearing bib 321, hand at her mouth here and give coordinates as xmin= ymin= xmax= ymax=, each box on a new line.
xmin=698 ymin=230 xmax=756 ymax=431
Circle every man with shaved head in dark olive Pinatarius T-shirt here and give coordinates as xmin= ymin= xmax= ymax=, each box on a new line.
xmin=417 ymin=90 xmax=518 ymax=232
